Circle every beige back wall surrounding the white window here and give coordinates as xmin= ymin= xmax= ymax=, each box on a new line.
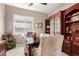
xmin=5 ymin=5 xmax=47 ymax=43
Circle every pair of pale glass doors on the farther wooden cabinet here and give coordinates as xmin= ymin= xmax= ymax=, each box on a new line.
xmin=50 ymin=17 xmax=61 ymax=35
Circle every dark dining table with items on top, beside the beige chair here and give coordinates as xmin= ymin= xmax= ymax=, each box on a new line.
xmin=25 ymin=37 xmax=40 ymax=56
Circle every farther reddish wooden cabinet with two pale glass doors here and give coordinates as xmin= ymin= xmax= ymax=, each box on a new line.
xmin=45 ymin=11 xmax=62 ymax=35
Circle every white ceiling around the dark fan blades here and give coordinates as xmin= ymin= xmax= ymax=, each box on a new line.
xmin=6 ymin=3 xmax=66 ymax=14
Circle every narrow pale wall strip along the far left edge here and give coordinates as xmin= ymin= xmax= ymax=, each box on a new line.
xmin=0 ymin=4 xmax=5 ymax=39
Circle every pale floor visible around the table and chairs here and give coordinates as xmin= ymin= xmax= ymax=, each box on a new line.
xmin=6 ymin=44 xmax=68 ymax=56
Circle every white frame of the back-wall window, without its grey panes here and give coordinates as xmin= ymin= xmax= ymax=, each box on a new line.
xmin=13 ymin=14 xmax=34 ymax=35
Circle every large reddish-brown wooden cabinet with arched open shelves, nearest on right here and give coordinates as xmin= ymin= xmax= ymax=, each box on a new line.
xmin=63 ymin=3 xmax=79 ymax=56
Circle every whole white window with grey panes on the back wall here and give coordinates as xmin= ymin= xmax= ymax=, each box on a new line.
xmin=13 ymin=15 xmax=34 ymax=34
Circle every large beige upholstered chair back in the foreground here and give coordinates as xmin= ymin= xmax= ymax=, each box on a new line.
xmin=41 ymin=35 xmax=64 ymax=56
